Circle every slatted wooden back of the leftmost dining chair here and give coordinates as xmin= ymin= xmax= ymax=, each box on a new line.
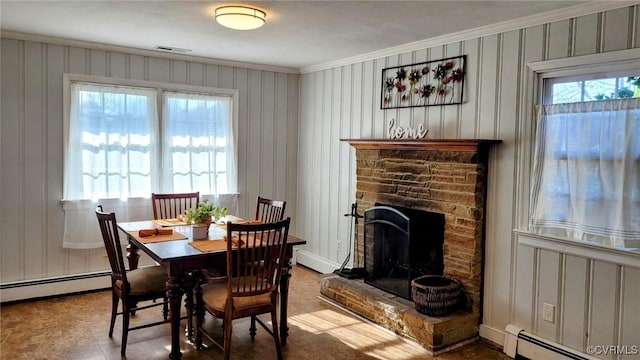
xmin=96 ymin=205 xmax=128 ymax=284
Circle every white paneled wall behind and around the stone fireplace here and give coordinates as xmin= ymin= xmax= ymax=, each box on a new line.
xmin=297 ymin=5 xmax=640 ymax=359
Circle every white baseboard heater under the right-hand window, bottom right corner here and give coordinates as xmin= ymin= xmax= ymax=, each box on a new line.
xmin=504 ymin=324 xmax=598 ymax=360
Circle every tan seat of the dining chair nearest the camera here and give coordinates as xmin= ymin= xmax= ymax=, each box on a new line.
xmin=202 ymin=277 xmax=271 ymax=313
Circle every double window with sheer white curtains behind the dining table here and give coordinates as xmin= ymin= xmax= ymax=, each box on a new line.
xmin=64 ymin=80 xmax=237 ymax=201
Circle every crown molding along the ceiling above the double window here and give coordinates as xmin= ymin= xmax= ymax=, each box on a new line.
xmin=0 ymin=31 xmax=300 ymax=74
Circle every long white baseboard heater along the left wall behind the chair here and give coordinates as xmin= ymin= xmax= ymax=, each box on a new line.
xmin=0 ymin=271 xmax=111 ymax=305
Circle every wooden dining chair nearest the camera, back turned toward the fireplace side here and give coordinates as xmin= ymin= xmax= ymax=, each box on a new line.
xmin=195 ymin=218 xmax=291 ymax=359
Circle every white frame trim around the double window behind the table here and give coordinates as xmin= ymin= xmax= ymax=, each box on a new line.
xmin=62 ymin=73 xmax=239 ymax=203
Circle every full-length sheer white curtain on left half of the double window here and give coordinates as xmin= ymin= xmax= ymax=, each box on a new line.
xmin=63 ymin=83 xmax=158 ymax=249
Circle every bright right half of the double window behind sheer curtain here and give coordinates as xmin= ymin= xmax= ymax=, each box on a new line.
xmin=162 ymin=91 xmax=238 ymax=195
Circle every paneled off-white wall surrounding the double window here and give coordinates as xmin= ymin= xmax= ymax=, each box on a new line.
xmin=0 ymin=37 xmax=299 ymax=283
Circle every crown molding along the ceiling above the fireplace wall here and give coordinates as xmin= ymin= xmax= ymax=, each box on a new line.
xmin=300 ymin=1 xmax=640 ymax=74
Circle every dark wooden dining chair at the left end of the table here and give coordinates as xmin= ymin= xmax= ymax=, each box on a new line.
xmin=96 ymin=205 xmax=169 ymax=356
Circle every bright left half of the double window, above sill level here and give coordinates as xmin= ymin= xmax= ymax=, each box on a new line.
xmin=64 ymin=83 xmax=158 ymax=200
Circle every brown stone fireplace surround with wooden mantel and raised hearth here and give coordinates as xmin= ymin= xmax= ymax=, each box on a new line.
xmin=321 ymin=139 xmax=500 ymax=354
